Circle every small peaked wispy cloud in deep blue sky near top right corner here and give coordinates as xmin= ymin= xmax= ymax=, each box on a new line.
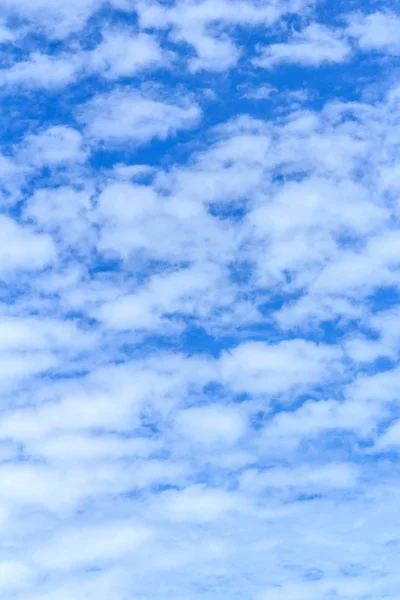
xmin=253 ymin=23 xmax=350 ymax=69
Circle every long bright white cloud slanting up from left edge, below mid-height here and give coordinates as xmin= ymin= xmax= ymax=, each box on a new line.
xmin=0 ymin=355 xmax=215 ymax=442
